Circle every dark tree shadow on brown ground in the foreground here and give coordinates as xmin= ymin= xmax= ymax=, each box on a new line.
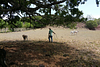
xmin=0 ymin=41 xmax=100 ymax=67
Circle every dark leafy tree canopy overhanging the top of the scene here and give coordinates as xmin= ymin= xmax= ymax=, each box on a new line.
xmin=0 ymin=0 xmax=99 ymax=24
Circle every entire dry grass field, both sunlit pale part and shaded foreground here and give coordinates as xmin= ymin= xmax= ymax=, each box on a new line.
xmin=0 ymin=27 xmax=100 ymax=67
